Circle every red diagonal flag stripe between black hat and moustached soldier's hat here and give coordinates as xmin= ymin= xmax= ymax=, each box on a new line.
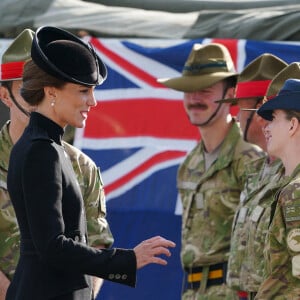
xmin=91 ymin=38 xmax=162 ymax=87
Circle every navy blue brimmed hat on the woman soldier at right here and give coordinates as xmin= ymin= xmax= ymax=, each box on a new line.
xmin=257 ymin=79 xmax=300 ymax=121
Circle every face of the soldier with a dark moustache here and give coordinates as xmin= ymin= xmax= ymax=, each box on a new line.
xmin=184 ymin=82 xmax=229 ymax=127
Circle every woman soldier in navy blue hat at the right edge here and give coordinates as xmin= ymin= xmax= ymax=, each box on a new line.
xmin=255 ymin=79 xmax=300 ymax=300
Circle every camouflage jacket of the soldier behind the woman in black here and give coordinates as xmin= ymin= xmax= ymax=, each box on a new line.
xmin=0 ymin=122 xmax=113 ymax=279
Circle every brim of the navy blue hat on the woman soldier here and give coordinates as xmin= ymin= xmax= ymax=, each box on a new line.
xmin=257 ymin=92 xmax=300 ymax=121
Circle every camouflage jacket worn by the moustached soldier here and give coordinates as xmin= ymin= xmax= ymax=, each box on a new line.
xmin=177 ymin=122 xmax=265 ymax=268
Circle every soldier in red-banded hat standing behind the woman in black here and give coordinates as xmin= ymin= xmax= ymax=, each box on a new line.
xmin=0 ymin=30 xmax=113 ymax=300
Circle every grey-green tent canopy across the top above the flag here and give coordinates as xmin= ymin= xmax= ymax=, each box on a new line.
xmin=0 ymin=0 xmax=300 ymax=41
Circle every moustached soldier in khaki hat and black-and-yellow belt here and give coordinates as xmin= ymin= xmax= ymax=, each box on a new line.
xmin=160 ymin=44 xmax=264 ymax=300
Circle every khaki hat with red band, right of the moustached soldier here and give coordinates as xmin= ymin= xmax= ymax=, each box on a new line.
xmin=216 ymin=53 xmax=288 ymax=105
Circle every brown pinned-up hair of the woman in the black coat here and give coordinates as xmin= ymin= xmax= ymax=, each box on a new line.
xmin=20 ymin=60 xmax=66 ymax=105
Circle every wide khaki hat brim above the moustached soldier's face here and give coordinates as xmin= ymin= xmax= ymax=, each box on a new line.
xmin=157 ymin=72 xmax=238 ymax=92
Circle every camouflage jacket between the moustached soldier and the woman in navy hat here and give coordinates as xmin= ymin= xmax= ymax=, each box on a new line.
xmin=227 ymin=157 xmax=283 ymax=292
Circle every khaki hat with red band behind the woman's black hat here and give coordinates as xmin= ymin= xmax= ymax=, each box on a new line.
xmin=0 ymin=29 xmax=34 ymax=81
